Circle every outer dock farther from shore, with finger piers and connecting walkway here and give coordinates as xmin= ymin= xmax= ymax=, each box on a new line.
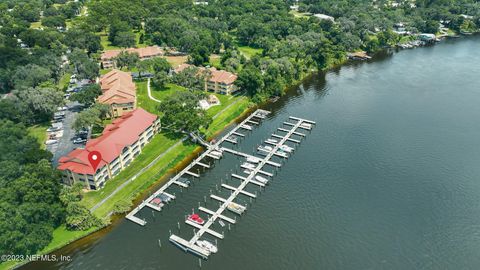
xmin=170 ymin=117 xmax=314 ymax=258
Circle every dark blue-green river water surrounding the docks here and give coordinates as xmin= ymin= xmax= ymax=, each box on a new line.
xmin=24 ymin=36 xmax=480 ymax=270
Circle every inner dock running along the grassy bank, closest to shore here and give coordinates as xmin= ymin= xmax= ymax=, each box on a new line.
xmin=126 ymin=109 xmax=270 ymax=226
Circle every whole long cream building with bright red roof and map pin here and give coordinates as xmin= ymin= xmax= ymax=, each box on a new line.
xmin=57 ymin=108 xmax=160 ymax=190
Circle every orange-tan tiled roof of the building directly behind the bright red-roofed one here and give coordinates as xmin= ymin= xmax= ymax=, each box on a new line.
xmin=97 ymin=69 xmax=136 ymax=104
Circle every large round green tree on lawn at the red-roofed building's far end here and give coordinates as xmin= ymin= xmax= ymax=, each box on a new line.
xmin=158 ymin=91 xmax=212 ymax=133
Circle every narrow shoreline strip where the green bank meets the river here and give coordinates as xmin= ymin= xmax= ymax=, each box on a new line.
xmin=8 ymin=34 xmax=477 ymax=269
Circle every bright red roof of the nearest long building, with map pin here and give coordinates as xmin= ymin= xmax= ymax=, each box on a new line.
xmin=57 ymin=108 xmax=157 ymax=175
